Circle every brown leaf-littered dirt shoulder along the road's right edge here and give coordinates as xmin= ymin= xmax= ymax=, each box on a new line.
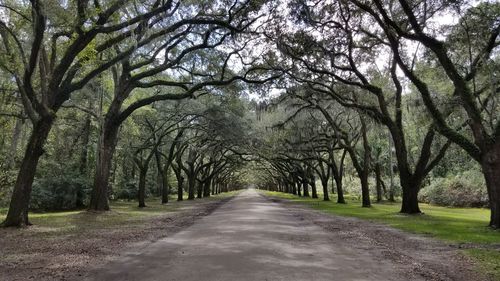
xmin=262 ymin=195 xmax=493 ymax=281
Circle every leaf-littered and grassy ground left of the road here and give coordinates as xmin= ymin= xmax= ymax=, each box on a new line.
xmin=0 ymin=192 xmax=235 ymax=281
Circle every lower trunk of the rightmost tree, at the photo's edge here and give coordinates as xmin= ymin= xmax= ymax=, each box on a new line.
xmin=481 ymin=141 xmax=500 ymax=229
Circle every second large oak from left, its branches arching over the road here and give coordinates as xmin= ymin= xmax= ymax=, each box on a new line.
xmin=89 ymin=1 xmax=282 ymax=210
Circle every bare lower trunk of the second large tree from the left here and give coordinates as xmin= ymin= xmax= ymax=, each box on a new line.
xmin=89 ymin=118 xmax=119 ymax=211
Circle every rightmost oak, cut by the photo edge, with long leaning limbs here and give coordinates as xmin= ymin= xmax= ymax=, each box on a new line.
xmin=346 ymin=0 xmax=500 ymax=228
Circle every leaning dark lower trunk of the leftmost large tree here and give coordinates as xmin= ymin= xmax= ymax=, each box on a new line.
xmin=2 ymin=117 xmax=54 ymax=226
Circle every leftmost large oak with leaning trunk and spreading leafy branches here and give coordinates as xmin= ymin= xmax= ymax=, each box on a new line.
xmin=0 ymin=0 xmax=178 ymax=226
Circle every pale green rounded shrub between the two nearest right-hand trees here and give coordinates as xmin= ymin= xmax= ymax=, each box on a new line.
xmin=419 ymin=170 xmax=488 ymax=207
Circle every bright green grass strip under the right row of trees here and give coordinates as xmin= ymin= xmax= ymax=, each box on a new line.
xmin=262 ymin=191 xmax=500 ymax=280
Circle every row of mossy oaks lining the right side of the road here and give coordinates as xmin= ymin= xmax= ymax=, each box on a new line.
xmin=252 ymin=0 xmax=500 ymax=228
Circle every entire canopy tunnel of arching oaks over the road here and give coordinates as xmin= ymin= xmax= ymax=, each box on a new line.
xmin=0 ymin=0 xmax=500 ymax=228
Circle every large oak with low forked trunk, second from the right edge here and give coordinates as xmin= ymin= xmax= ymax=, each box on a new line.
xmin=269 ymin=1 xmax=449 ymax=214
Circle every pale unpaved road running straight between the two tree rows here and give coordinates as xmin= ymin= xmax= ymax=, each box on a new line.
xmin=87 ymin=190 xmax=479 ymax=281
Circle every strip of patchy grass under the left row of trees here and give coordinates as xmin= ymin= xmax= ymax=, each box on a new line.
xmin=0 ymin=191 xmax=237 ymax=236
